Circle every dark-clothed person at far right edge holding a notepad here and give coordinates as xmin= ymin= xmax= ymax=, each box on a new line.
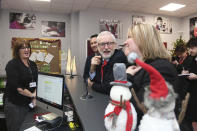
xmin=182 ymin=37 xmax=197 ymax=131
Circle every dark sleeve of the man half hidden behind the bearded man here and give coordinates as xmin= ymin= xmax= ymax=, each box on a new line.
xmin=83 ymin=55 xmax=95 ymax=82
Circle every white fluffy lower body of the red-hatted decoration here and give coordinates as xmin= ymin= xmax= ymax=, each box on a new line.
xmin=139 ymin=113 xmax=180 ymax=131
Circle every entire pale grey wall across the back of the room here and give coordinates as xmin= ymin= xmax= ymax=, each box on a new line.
xmin=0 ymin=8 xmax=185 ymax=75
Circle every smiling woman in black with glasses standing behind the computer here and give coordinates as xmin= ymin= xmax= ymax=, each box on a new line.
xmin=4 ymin=42 xmax=38 ymax=131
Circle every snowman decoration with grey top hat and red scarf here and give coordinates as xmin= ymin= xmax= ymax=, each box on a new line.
xmin=104 ymin=63 xmax=137 ymax=131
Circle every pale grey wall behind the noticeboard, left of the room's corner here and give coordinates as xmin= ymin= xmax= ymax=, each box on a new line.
xmin=0 ymin=10 xmax=71 ymax=75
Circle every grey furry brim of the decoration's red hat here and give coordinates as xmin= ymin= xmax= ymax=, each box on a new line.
xmin=144 ymin=82 xmax=177 ymax=110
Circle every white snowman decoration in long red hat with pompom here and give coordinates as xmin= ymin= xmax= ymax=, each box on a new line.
xmin=128 ymin=53 xmax=180 ymax=131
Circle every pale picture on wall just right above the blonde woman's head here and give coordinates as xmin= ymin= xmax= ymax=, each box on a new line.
xmin=155 ymin=16 xmax=172 ymax=34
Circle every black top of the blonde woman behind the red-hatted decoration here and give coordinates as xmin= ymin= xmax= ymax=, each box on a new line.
xmin=127 ymin=58 xmax=178 ymax=125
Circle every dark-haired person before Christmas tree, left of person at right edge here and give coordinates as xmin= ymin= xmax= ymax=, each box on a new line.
xmin=172 ymin=44 xmax=192 ymax=74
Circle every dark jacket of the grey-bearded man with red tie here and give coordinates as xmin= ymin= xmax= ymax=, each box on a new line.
xmin=92 ymin=50 xmax=128 ymax=94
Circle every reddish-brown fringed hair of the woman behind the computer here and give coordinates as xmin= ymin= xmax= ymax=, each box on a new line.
xmin=13 ymin=41 xmax=31 ymax=58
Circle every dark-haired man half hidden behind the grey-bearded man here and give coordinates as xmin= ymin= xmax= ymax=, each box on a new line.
xmin=83 ymin=34 xmax=99 ymax=86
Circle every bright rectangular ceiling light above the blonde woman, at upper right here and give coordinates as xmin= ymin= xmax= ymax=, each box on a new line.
xmin=160 ymin=3 xmax=185 ymax=11
